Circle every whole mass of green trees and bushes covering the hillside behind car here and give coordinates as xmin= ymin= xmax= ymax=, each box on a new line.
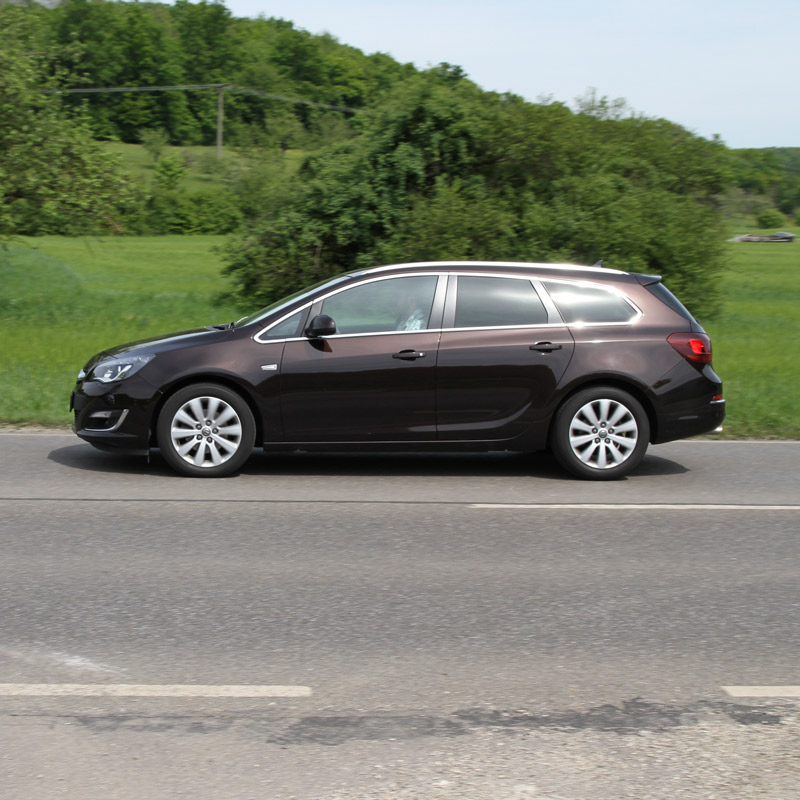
xmin=0 ymin=0 xmax=800 ymax=314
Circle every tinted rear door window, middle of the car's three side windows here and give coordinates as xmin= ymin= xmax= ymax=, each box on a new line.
xmin=455 ymin=275 xmax=547 ymax=328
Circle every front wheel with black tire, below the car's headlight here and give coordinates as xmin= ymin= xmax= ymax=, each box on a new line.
xmin=156 ymin=383 xmax=256 ymax=478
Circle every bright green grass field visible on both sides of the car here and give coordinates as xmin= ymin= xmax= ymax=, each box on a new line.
xmin=0 ymin=228 xmax=800 ymax=439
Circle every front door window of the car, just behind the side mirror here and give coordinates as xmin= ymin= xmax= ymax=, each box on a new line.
xmin=321 ymin=275 xmax=439 ymax=334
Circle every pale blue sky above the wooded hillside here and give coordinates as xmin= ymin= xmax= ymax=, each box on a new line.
xmin=220 ymin=0 xmax=800 ymax=147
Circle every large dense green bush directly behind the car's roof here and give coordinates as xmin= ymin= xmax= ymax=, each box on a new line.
xmin=223 ymin=68 xmax=729 ymax=314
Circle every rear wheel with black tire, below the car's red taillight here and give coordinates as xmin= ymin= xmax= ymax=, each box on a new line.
xmin=550 ymin=386 xmax=650 ymax=481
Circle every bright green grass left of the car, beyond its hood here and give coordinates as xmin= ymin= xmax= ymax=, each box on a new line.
xmin=0 ymin=236 xmax=241 ymax=426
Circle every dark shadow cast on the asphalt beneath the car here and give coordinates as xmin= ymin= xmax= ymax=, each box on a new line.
xmin=48 ymin=444 xmax=689 ymax=481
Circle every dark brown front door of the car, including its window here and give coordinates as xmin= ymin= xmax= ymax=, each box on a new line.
xmin=281 ymin=274 xmax=444 ymax=442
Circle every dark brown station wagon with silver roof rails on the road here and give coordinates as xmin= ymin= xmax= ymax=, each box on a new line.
xmin=71 ymin=262 xmax=725 ymax=480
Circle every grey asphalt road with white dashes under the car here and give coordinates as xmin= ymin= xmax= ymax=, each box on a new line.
xmin=0 ymin=433 xmax=800 ymax=800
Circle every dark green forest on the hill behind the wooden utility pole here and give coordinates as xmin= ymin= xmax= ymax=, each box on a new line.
xmin=4 ymin=0 xmax=416 ymax=147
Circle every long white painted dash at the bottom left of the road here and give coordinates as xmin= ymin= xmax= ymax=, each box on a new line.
xmin=0 ymin=683 xmax=311 ymax=697
